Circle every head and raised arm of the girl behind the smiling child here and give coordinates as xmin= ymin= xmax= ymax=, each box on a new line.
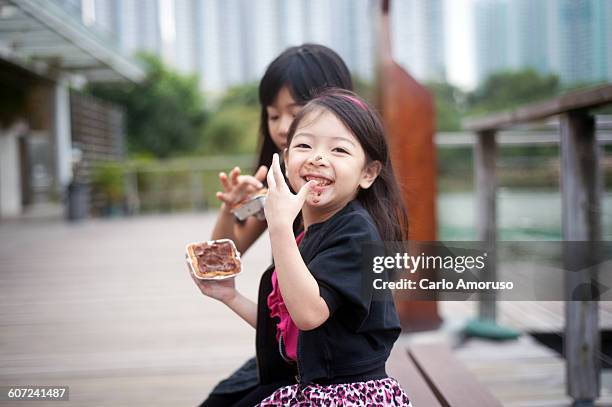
xmin=211 ymin=44 xmax=353 ymax=253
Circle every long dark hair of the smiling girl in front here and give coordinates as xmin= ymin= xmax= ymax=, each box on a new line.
xmin=287 ymin=89 xmax=408 ymax=242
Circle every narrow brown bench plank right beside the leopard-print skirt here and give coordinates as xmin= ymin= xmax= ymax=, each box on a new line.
xmin=387 ymin=343 xmax=441 ymax=407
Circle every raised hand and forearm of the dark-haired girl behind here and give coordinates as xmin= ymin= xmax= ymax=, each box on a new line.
xmin=211 ymin=166 xmax=267 ymax=253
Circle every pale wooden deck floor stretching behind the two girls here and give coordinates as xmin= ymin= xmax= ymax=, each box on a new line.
xmin=0 ymin=213 xmax=612 ymax=407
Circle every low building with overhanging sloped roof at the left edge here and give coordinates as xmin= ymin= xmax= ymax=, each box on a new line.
xmin=0 ymin=0 xmax=145 ymax=218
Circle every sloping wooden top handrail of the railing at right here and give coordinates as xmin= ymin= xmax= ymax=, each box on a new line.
xmin=463 ymin=84 xmax=612 ymax=132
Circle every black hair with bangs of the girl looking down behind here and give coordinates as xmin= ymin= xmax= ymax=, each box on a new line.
xmin=256 ymin=44 xmax=353 ymax=169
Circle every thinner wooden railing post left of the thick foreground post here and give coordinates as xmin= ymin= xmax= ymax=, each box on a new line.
xmin=474 ymin=130 xmax=497 ymax=322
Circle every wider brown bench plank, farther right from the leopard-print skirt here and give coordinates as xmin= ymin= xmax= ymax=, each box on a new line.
xmin=408 ymin=344 xmax=502 ymax=407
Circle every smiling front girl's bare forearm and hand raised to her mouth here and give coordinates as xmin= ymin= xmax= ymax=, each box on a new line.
xmin=265 ymin=154 xmax=329 ymax=331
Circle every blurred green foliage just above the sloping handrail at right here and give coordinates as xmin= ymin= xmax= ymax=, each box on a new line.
xmin=469 ymin=69 xmax=561 ymax=114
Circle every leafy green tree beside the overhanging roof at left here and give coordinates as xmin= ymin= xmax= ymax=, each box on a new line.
xmin=88 ymin=54 xmax=206 ymax=157
